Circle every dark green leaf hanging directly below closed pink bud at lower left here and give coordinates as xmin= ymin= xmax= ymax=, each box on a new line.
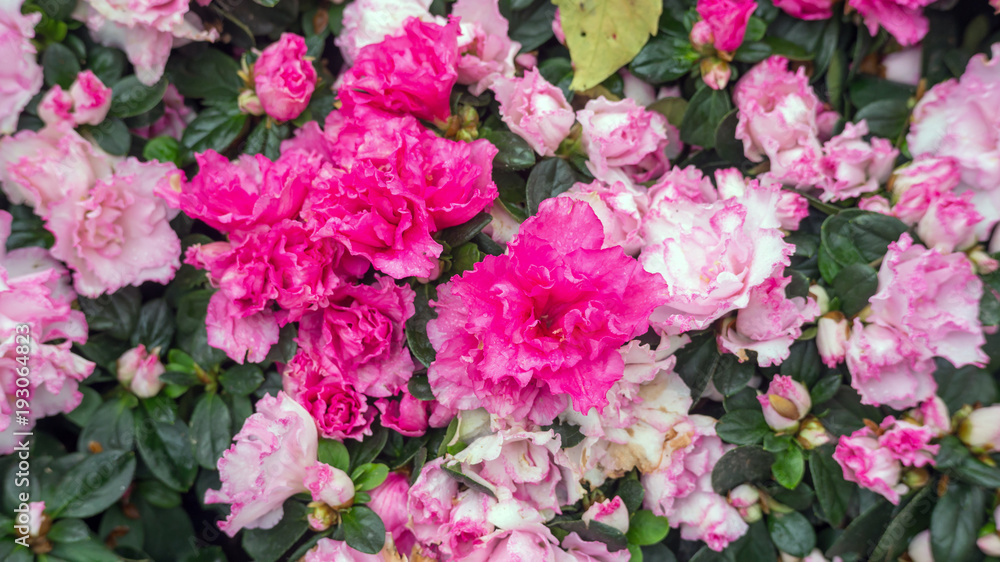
xmin=136 ymin=400 xmax=198 ymax=492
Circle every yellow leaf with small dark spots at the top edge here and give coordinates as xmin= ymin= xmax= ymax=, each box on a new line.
xmin=552 ymin=0 xmax=663 ymax=91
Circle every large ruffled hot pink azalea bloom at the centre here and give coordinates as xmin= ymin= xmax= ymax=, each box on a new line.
xmin=428 ymin=198 xmax=659 ymax=424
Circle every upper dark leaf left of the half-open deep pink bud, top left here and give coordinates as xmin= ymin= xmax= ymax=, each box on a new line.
xmin=167 ymin=48 xmax=243 ymax=101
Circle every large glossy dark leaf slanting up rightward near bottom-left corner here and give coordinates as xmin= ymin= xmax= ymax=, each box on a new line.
xmin=46 ymin=450 xmax=135 ymax=518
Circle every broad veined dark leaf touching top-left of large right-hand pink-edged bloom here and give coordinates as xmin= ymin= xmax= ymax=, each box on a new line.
xmin=820 ymin=209 xmax=907 ymax=284
